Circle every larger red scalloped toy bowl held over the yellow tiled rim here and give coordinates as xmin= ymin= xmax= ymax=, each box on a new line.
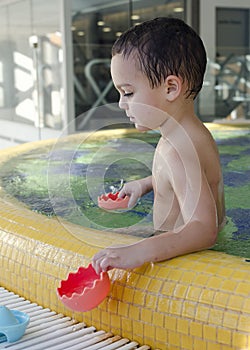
xmin=57 ymin=264 xmax=110 ymax=312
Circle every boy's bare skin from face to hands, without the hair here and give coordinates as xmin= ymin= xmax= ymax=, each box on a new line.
xmin=92 ymin=19 xmax=225 ymax=273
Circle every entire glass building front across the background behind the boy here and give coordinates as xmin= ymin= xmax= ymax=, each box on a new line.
xmin=0 ymin=0 xmax=250 ymax=146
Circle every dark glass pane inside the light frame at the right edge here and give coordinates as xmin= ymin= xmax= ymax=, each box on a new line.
xmin=215 ymin=7 xmax=250 ymax=119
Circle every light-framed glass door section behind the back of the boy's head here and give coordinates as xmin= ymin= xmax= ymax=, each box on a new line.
xmin=197 ymin=0 xmax=250 ymax=123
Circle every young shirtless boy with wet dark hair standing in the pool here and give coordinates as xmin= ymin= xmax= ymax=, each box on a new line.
xmin=92 ymin=18 xmax=225 ymax=273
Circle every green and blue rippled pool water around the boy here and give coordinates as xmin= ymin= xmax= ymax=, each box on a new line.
xmin=0 ymin=128 xmax=250 ymax=258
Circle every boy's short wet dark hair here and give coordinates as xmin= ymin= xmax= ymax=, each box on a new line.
xmin=112 ymin=17 xmax=207 ymax=98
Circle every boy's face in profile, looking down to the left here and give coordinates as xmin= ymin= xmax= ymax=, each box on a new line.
xmin=111 ymin=54 xmax=169 ymax=131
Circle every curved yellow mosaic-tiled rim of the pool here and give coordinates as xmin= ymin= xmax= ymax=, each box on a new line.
xmin=0 ymin=135 xmax=250 ymax=350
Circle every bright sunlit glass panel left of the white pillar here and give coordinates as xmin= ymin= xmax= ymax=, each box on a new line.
xmin=0 ymin=0 xmax=62 ymax=142
